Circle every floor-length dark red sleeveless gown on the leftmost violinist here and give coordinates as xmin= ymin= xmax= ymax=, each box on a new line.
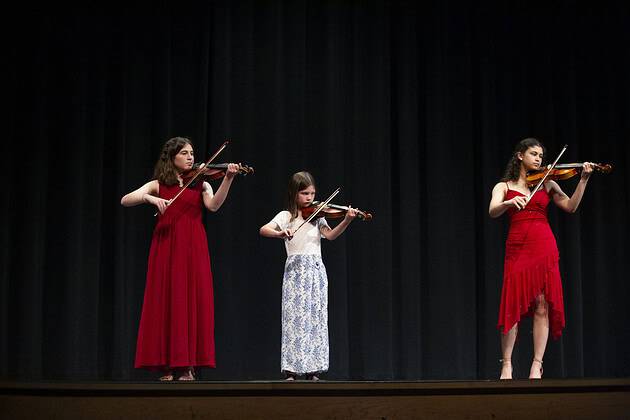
xmin=135 ymin=182 xmax=215 ymax=370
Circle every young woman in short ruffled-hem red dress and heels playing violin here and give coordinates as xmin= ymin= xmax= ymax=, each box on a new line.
xmin=489 ymin=138 xmax=593 ymax=379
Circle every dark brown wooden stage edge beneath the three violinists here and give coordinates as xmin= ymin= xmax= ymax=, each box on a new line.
xmin=0 ymin=378 xmax=630 ymax=420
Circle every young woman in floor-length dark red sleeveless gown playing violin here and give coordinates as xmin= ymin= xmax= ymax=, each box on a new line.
xmin=121 ymin=137 xmax=238 ymax=381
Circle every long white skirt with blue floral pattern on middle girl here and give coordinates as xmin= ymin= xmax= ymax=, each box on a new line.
xmin=281 ymin=254 xmax=329 ymax=374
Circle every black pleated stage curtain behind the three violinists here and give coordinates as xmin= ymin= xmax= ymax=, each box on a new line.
xmin=0 ymin=0 xmax=630 ymax=380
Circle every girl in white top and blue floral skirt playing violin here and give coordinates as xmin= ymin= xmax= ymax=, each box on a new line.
xmin=260 ymin=172 xmax=357 ymax=381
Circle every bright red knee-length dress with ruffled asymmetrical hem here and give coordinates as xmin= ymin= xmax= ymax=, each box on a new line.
xmin=497 ymin=187 xmax=565 ymax=339
